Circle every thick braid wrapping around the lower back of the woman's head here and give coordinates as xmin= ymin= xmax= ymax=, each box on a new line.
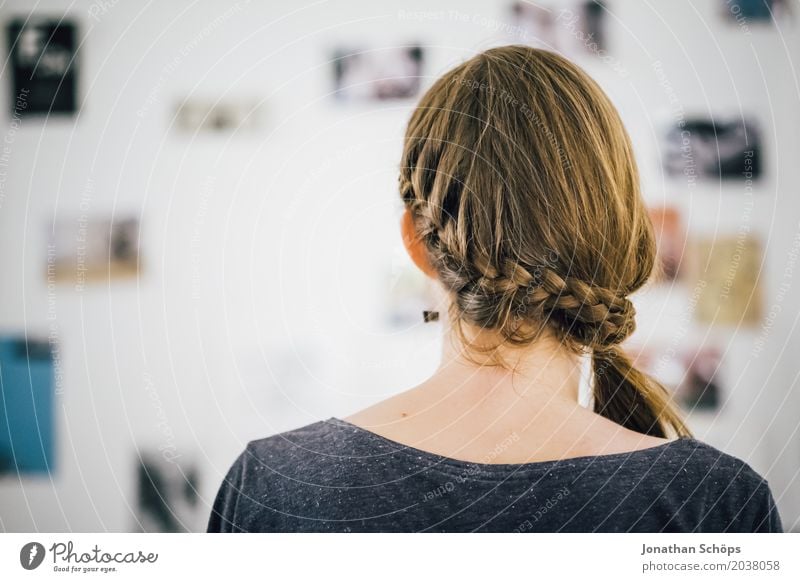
xmin=400 ymin=175 xmax=636 ymax=351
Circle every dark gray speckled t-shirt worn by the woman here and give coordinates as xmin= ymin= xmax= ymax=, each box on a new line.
xmin=208 ymin=418 xmax=782 ymax=532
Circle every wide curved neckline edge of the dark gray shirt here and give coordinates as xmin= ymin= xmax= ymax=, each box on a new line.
xmin=327 ymin=417 xmax=695 ymax=473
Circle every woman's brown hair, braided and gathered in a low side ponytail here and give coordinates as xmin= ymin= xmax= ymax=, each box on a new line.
xmin=400 ymin=46 xmax=691 ymax=437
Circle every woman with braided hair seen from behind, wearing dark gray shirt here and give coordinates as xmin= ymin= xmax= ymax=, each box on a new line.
xmin=208 ymin=46 xmax=782 ymax=532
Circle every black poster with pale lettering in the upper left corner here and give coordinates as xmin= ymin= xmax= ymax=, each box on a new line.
xmin=7 ymin=18 xmax=78 ymax=116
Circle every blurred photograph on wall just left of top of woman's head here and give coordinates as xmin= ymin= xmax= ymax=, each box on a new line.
xmin=333 ymin=46 xmax=424 ymax=101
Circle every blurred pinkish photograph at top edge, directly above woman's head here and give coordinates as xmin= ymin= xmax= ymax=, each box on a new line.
xmin=511 ymin=0 xmax=608 ymax=55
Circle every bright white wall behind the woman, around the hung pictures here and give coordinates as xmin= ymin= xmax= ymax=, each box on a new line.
xmin=0 ymin=0 xmax=800 ymax=531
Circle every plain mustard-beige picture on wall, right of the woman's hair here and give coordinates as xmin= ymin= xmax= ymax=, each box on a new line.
xmin=687 ymin=235 xmax=763 ymax=327
